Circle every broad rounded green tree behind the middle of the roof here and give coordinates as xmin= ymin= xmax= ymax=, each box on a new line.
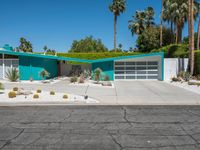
xmin=69 ymin=36 xmax=108 ymax=53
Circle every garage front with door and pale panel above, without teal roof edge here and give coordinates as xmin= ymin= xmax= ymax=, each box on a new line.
xmin=114 ymin=55 xmax=162 ymax=80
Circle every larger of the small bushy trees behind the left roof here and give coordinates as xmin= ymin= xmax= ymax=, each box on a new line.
xmin=17 ymin=37 xmax=33 ymax=52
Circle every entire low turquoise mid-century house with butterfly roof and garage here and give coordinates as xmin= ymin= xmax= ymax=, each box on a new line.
xmin=0 ymin=45 xmax=164 ymax=80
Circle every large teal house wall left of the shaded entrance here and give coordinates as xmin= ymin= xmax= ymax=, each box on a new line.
xmin=19 ymin=56 xmax=58 ymax=80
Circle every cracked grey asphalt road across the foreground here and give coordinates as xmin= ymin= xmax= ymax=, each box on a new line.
xmin=0 ymin=106 xmax=200 ymax=150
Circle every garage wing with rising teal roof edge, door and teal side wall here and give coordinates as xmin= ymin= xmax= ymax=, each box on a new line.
xmin=92 ymin=52 xmax=164 ymax=81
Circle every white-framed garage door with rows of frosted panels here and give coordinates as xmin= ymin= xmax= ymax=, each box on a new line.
xmin=114 ymin=61 xmax=158 ymax=80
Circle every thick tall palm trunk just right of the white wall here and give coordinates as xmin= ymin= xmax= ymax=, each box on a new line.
xmin=188 ymin=0 xmax=194 ymax=75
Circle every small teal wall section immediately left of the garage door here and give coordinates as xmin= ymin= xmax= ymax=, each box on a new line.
xmin=92 ymin=61 xmax=114 ymax=81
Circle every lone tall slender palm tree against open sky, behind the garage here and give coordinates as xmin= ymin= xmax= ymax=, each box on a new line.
xmin=109 ymin=0 xmax=126 ymax=51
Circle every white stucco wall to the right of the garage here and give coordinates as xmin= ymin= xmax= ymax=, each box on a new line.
xmin=164 ymin=58 xmax=188 ymax=81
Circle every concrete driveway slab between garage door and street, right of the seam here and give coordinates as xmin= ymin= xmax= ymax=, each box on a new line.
xmin=115 ymin=81 xmax=200 ymax=105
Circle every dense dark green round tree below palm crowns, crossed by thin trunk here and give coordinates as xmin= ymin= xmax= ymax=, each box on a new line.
xmin=136 ymin=26 xmax=173 ymax=52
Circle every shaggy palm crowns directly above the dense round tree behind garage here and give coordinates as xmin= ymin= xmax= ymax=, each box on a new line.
xmin=129 ymin=7 xmax=155 ymax=35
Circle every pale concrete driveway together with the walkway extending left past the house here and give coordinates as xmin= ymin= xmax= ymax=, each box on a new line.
xmin=2 ymin=80 xmax=200 ymax=105
